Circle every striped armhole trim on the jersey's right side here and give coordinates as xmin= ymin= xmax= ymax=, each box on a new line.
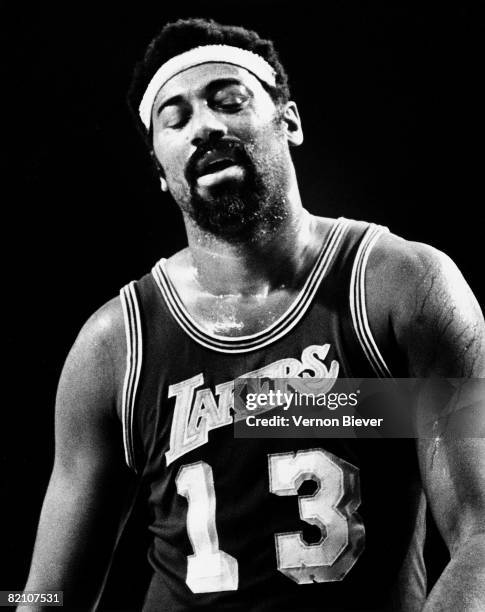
xmin=350 ymin=223 xmax=392 ymax=378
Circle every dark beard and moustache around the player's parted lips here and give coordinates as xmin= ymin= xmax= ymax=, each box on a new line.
xmin=182 ymin=133 xmax=288 ymax=243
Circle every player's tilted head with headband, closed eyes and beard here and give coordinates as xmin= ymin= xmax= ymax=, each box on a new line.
xmin=129 ymin=19 xmax=302 ymax=237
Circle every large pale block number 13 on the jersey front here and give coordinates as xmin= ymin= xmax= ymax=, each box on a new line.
xmin=176 ymin=449 xmax=365 ymax=593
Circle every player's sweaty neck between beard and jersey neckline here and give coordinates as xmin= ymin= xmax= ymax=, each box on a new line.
xmin=180 ymin=183 xmax=318 ymax=296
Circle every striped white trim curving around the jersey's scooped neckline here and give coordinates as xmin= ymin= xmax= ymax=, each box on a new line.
xmin=152 ymin=218 xmax=350 ymax=353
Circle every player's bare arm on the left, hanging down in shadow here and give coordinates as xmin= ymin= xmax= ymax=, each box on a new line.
xmin=21 ymin=300 xmax=136 ymax=610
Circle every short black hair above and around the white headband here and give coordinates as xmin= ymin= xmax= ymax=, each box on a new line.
xmin=128 ymin=18 xmax=290 ymax=142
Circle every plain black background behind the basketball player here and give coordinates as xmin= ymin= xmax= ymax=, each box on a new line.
xmin=0 ymin=0 xmax=485 ymax=609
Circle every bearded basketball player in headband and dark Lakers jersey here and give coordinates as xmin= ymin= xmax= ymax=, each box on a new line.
xmin=22 ymin=20 xmax=485 ymax=612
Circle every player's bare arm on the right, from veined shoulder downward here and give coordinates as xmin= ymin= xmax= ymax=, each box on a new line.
xmin=370 ymin=243 xmax=485 ymax=612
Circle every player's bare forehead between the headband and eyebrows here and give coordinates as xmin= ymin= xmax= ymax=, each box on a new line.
xmin=155 ymin=62 xmax=266 ymax=103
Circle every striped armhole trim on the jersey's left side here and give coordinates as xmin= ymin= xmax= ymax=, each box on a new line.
xmin=120 ymin=282 xmax=143 ymax=472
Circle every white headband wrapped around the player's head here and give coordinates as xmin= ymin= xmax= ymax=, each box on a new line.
xmin=138 ymin=45 xmax=276 ymax=130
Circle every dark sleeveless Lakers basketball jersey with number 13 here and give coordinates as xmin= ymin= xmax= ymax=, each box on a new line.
xmin=121 ymin=218 xmax=426 ymax=612
